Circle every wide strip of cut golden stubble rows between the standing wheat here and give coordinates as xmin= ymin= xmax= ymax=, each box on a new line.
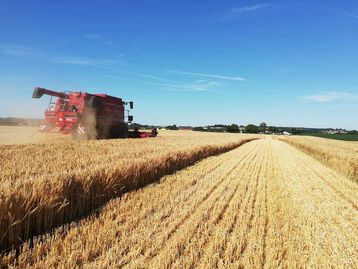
xmin=3 ymin=138 xmax=358 ymax=268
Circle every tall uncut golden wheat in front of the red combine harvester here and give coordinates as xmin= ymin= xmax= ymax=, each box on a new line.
xmin=0 ymin=132 xmax=254 ymax=250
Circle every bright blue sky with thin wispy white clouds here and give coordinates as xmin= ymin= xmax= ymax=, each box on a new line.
xmin=0 ymin=0 xmax=358 ymax=129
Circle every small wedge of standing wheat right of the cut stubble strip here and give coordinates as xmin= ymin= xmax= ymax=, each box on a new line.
xmin=279 ymin=136 xmax=358 ymax=183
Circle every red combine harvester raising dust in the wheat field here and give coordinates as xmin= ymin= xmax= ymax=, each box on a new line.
xmin=32 ymin=87 xmax=157 ymax=139
